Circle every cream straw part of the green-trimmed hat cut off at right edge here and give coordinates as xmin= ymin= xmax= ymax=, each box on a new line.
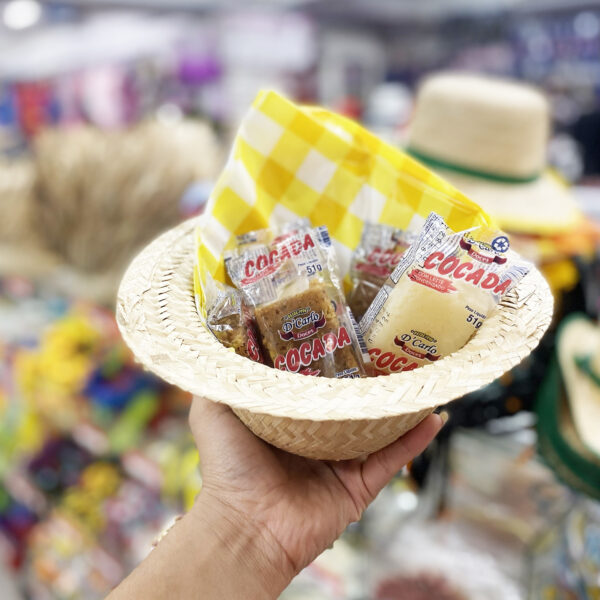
xmin=558 ymin=316 xmax=600 ymax=457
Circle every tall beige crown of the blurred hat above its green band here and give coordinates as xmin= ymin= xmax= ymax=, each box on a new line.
xmin=409 ymin=73 xmax=550 ymax=177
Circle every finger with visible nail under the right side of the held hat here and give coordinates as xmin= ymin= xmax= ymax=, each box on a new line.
xmin=362 ymin=415 xmax=444 ymax=498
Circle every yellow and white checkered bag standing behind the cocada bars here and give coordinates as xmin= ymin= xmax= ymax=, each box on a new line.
xmin=194 ymin=91 xmax=490 ymax=314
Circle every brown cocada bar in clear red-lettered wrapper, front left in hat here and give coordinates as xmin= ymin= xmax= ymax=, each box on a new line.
xmin=225 ymin=227 xmax=368 ymax=379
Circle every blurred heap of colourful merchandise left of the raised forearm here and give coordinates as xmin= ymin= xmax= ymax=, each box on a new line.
xmin=0 ymin=278 xmax=201 ymax=600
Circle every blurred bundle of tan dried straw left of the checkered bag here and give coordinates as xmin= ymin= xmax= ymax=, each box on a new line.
xmin=34 ymin=121 xmax=221 ymax=275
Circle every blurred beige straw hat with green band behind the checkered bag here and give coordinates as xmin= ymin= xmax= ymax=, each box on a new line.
xmin=408 ymin=73 xmax=581 ymax=235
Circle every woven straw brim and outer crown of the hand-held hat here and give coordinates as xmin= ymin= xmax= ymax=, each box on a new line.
xmin=117 ymin=219 xmax=553 ymax=460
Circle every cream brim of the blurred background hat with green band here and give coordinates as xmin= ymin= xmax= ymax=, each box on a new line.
xmin=436 ymin=169 xmax=582 ymax=235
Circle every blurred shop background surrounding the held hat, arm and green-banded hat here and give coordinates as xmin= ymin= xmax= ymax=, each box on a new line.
xmin=0 ymin=0 xmax=600 ymax=600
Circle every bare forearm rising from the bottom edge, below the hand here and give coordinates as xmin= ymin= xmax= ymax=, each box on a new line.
xmin=107 ymin=494 xmax=293 ymax=600
